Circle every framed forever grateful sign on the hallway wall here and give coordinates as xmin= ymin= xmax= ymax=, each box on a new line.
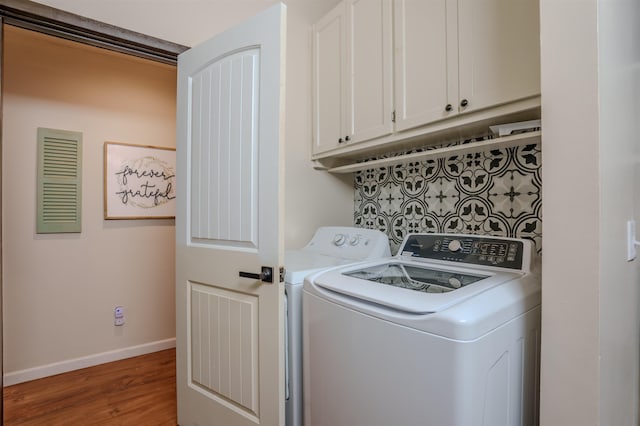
xmin=104 ymin=142 xmax=176 ymax=219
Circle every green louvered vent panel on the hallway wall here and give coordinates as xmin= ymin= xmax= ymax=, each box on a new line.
xmin=36 ymin=128 xmax=82 ymax=234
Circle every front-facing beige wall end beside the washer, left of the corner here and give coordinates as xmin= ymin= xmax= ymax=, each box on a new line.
xmin=540 ymin=0 xmax=600 ymax=426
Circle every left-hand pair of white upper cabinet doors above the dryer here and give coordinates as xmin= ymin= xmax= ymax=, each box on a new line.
xmin=313 ymin=0 xmax=393 ymax=154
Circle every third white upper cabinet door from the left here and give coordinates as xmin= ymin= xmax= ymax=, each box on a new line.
xmin=394 ymin=0 xmax=458 ymax=131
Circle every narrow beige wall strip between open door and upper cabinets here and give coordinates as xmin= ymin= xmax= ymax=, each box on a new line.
xmin=285 ymin=0 xmax=354 ymax=249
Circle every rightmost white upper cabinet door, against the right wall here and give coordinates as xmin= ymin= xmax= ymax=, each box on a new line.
xmin=458 ymin=0 xmax=540 ymax=111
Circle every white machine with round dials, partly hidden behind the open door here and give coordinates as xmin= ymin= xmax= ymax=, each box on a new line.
xmin=284 ymin=226 xmax=390 ymax=426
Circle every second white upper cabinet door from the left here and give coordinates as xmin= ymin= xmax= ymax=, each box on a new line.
xmin=345 ymin=0 xmax=393 ymax=143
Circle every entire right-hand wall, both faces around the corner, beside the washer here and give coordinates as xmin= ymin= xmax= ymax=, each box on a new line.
xmin=541 ymin=0 xmax=640 ymax=426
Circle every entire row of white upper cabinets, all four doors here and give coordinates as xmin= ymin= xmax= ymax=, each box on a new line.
xmin=313 ymin=0 xmax=540 ymax=158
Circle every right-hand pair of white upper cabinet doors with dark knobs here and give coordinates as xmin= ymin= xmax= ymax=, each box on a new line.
xmin=394 ymin=0 xmax=540 ymax=131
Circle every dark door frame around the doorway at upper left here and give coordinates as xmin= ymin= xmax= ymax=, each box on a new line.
xmin=0 ymin=0 xmax=188 ymax=424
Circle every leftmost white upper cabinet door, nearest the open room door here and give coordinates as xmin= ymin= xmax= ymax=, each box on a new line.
xmin=313 ymin=3 xmax=347 ymax=154
